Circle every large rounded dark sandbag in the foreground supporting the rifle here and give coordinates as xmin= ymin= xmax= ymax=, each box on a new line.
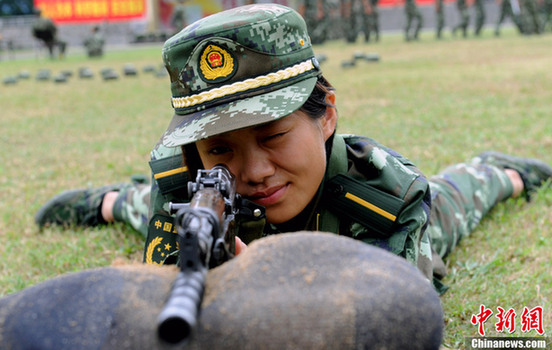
xmin=0 ymin=232 xmax=443 ymax=350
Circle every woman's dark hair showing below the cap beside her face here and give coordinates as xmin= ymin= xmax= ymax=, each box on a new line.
xmin=182 ymin=75 xmax=335 ymax=179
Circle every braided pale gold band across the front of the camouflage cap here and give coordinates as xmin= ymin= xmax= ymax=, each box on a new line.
xmin=172 ymin=59 xmax=316 ymax=108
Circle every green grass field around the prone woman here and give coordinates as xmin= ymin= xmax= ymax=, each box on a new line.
xmin=0 ymin=31 xmax=552 ymax=349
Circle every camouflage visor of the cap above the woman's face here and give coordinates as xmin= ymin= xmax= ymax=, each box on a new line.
xmin=162 ymin=77 xmax=317 ymax=147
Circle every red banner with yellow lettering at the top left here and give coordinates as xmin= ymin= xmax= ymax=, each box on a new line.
xmin=34 ymin=0 xmax=146 ymax=22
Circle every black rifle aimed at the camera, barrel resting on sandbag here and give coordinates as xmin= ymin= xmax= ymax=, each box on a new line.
xmin=157 ymin=165 xmax=265 ymax=344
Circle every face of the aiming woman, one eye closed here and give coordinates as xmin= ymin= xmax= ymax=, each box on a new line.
xmin=196 ymin=98 xmax=337 ymax=224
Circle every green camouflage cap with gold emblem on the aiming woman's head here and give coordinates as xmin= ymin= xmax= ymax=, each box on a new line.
xmin=162 ymin=4 xmax=321 ymax=147
